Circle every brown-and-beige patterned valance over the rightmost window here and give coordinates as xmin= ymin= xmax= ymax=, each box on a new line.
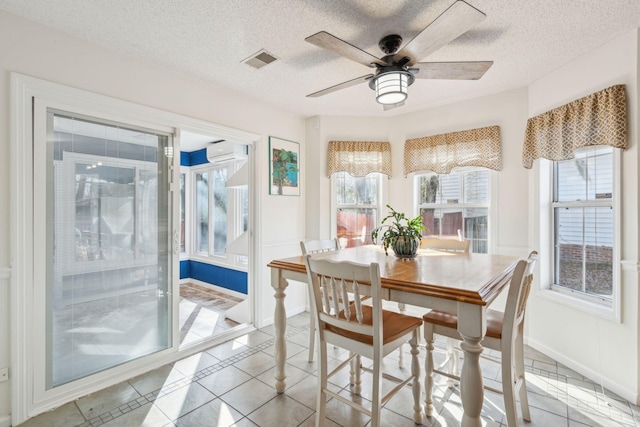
xmin=522 ymin=85 xmax=627 ymax=169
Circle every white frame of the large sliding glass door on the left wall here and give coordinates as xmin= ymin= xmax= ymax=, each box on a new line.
xmin=9 ymin=73 xmax=260 ymax=425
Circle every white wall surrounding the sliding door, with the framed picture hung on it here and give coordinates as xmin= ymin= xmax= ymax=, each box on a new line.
xmin=0 ymin=12 xmax=305 ymax=426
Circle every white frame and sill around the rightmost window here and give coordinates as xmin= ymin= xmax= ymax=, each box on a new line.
xmin=534 ymin=148 xmax=622 ymax=323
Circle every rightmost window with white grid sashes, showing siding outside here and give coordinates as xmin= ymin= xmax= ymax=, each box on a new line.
xmin=552 ymin=146 xmax=615 ymax=304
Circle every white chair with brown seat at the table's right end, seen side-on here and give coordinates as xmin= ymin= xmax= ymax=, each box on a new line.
xmin=423 ymin=251 xmax=538 ymax=427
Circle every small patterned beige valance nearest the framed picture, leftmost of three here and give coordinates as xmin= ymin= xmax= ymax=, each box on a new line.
xmin=327 ymin=141 xmax=391 ymax=178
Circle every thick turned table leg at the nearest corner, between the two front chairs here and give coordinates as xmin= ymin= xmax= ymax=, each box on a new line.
xmin=458 ymin=304 xmax=486 ymax=427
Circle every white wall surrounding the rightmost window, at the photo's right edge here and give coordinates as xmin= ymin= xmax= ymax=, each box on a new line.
xmin=527 ymin=30 xmax=639 ymax=401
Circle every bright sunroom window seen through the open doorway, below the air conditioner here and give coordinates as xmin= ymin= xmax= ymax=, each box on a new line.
xmin=193 ymin=161 xmax=248 ymax=264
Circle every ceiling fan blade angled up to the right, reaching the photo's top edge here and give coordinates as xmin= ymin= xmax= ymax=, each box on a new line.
xmin=393 ymin=0 xmax=486 ymax=64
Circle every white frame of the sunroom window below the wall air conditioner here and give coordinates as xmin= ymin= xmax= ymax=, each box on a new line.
xmin=187 ymin=160 xmax=247 ymax=271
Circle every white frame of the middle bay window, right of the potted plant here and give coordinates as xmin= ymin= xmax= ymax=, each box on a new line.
xmin=412 ymin=166 xmax=498 ymax=254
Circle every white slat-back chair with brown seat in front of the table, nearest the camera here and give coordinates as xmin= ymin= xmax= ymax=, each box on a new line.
xmin=305 ymin=255 xmax=422 ymax=427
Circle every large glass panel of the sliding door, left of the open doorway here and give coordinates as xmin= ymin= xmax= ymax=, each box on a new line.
xmin=44 ymin=109 xmax=172 ymax=390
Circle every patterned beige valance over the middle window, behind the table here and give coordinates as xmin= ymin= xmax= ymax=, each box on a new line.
xmin=404 ymin=126 xmax=502 ymax=176
